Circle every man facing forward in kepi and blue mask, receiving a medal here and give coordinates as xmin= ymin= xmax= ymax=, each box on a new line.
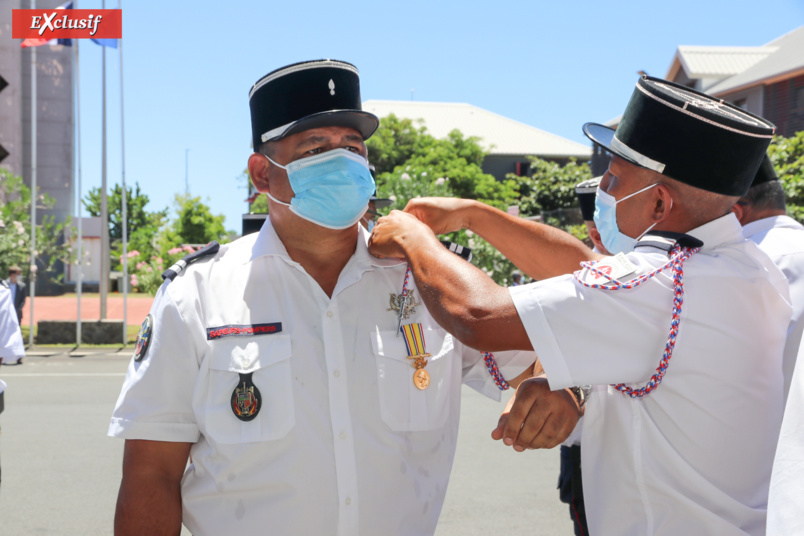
xmin=109 ymin=60 xmax=535 ymax=536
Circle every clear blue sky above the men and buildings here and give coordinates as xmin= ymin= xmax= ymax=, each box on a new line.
xmin=70 ymin=0 xmax=804 ymax=231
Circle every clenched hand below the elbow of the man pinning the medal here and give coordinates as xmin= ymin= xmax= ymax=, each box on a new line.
xmin=491 ymin=376 xmax=582 ymax=452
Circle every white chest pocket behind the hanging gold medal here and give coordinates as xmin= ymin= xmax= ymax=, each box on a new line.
xmin=371 ymin=330 xmax=460 ymax=432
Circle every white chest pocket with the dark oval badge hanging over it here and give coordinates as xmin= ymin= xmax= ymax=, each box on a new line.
xmin=203 ymin=334 xmax=296 ymax=444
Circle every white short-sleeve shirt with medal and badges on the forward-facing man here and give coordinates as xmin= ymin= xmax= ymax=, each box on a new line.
xmin=109 ymin=221 xmax=535 ymax=536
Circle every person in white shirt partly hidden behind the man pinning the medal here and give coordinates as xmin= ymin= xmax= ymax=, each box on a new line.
xmin=732 ymin=155 xmax=804 ymax=400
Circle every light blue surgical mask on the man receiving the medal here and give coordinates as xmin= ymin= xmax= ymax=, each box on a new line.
xmin=266 ymin=149 xmax=374 ymax=229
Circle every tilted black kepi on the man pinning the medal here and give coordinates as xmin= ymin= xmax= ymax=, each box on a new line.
xmin=583 ymin=76 xmax=776 ymax=196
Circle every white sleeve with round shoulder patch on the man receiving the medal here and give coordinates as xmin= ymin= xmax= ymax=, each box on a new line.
xmin=108 ymin=283 xmax=205 ymax=443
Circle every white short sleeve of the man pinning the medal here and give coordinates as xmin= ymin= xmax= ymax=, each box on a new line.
xmin=509 ymin=274 xmax=673 ymax=390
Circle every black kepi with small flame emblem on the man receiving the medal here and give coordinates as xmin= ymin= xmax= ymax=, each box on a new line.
xmin=249 ymin=60 xmax=380 ymax=151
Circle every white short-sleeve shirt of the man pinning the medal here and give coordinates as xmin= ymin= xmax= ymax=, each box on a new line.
xmin=511 ymin=214 xmax=791 ymax=536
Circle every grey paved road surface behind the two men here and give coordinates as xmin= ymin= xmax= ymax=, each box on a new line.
xmin=0 ymin=350 xmax=572 ymax=536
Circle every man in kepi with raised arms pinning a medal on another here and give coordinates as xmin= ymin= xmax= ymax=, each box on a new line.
xmin=370 ymin=77 xmax=791 ymax=536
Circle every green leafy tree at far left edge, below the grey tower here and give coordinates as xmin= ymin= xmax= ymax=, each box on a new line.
xmin=0 ymin=168 xmax=72 ymax=284
